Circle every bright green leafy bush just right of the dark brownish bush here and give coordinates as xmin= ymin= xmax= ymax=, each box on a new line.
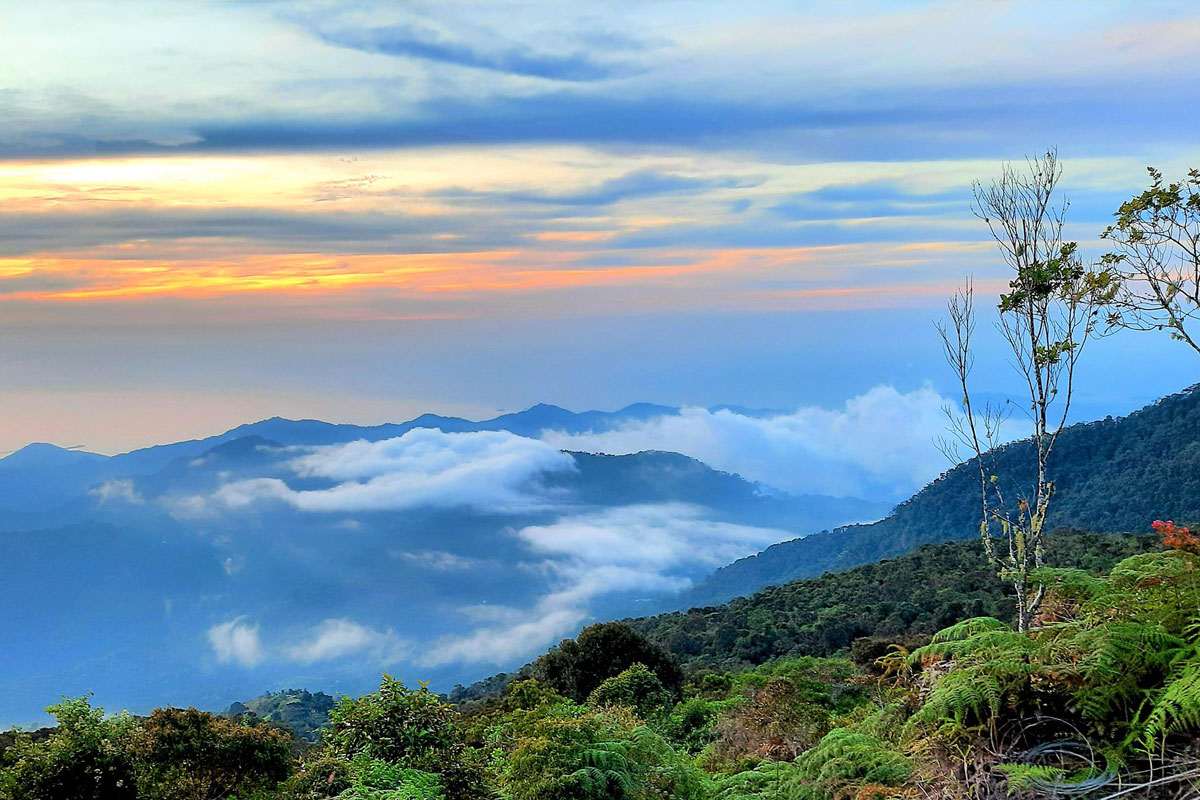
xmin=324 ymin=675 xmax=484 ymax=799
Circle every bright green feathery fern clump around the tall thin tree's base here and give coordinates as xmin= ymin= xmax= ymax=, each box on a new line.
xmin=906 ymin=551 xmax=1200 ymax=750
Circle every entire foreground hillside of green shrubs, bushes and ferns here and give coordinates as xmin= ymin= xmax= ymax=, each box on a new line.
xmin=9 ymin=525 xmax=1200 ymax=800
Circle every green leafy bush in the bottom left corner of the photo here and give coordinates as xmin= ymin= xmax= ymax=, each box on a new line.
xmin=0 ymin=697 xmax=137 ymax=800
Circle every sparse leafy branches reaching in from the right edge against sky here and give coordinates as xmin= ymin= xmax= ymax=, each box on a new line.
xmin=1102 ymin=167 xmax=1200 ymax=353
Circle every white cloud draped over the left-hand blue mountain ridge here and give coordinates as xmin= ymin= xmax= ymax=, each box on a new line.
xmin=212 ymin=428 xmax=575 ymax=512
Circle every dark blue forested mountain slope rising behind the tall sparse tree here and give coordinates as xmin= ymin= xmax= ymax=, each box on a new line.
xmin=685 ymin=386 xmax=1200 ymax=606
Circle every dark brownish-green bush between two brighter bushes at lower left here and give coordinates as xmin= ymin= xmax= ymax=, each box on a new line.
xmin=130 ymin=709 xmax=292 ymax=800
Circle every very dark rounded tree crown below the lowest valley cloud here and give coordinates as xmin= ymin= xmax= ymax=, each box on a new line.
xmin=533 ymin=622 xmax=683 ymax=703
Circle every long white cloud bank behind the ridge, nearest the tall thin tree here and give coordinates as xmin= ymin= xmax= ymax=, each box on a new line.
xmin=542 ymin=386 xmax=964 ymax=499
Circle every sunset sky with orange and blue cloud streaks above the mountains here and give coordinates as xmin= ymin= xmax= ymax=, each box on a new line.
xmin=0 ymin=0 xmax=1200 ymax=452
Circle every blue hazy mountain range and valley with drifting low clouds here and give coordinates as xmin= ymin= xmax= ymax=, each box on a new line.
xmin=0 ymin=404 xmax=887 ymax=727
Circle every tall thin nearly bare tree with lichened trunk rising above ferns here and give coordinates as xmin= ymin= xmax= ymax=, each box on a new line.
xmin=938 ymin=151 xmax=1116 ymax=631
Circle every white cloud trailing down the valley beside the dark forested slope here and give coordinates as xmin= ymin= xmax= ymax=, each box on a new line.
xmin=420 ymin=503 xmax=792 ymax=667
